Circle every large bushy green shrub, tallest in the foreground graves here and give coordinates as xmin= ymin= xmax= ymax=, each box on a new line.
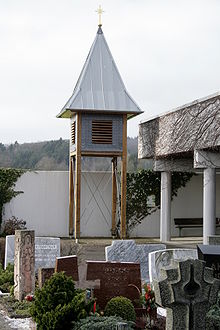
xmin=30 ymin=273 xmax=89 ymax=330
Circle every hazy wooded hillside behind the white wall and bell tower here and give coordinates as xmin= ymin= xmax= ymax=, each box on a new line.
xmin=0 ymin=137 xmax=151 ymax=172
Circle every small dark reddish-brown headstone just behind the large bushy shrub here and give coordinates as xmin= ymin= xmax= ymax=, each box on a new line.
xmin=55 ymin=256 xmax=79 ymax=281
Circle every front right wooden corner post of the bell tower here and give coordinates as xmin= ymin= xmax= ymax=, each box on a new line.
xmin=121 ymin=115 xmax=127 ymax=238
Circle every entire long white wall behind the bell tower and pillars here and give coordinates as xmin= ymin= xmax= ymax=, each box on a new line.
xmin=3 ymin=171 xmax=220 ymax=237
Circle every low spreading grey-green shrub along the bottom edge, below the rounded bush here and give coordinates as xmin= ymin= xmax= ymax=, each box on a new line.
xmin=72 ymin=316 xmax=133 ymax=330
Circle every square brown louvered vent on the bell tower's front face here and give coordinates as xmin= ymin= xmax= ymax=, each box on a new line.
xmin=92 ymin=120 xmax=112 ymax=144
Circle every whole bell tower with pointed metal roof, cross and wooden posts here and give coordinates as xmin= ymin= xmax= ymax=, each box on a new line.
xmin=57 ymin=18 xmax=142 ymax=239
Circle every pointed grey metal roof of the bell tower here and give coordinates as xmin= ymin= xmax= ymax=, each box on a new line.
xmin=57 ymin=25 xmax=142 ymax=118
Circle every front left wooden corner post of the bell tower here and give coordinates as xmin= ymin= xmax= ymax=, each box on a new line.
xmin=75 ymin=114 xmax=82 ymax=239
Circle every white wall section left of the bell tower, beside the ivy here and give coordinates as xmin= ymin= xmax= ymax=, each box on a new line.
xmin=3 ymin=171 xmax=68 ymax=236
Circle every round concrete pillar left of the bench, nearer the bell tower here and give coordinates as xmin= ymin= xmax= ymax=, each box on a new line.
xmin=160 ymin=172 xmax=171 ymax=242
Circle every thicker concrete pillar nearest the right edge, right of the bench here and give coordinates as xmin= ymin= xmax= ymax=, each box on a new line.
xmin=203 ymin=167 xmax=216 ymax=244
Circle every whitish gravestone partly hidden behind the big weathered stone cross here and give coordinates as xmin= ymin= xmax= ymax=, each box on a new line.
xmin=148 ymin=249 xmax=198 ymax=283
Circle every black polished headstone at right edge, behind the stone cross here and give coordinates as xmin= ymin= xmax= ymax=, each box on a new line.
xmin=197 ymin=244 xmax=220 ymax=279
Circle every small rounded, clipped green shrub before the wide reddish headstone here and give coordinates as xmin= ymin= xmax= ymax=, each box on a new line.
xmin=105 ymin=297 xmax=136 ymax=322
